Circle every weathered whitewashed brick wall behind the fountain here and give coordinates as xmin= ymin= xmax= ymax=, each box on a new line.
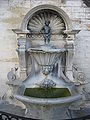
xmin=0 ymin=0 xmax=90 ymax=96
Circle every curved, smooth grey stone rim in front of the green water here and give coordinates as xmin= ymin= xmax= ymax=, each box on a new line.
xmin=14 ymin=94 xmax=82 ymax=105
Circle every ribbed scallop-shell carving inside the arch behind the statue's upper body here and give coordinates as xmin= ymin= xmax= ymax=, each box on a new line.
xmin=27 ymin=9 xmax=65 ymax=34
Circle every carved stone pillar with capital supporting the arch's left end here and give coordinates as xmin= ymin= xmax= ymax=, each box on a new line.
xmin=13 ymin=30 xmax=27 ymax=80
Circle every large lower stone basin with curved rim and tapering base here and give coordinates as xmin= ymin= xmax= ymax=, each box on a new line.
xmin=14 ymin=94 xmax=81 ymax=120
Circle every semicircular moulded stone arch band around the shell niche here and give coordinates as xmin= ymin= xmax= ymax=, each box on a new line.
xmin=20 ymin=4 xmax=72 ymax=31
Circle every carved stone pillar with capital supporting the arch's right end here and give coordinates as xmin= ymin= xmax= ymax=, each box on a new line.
xmin=65 ymin=30 xmax=79 ymax=81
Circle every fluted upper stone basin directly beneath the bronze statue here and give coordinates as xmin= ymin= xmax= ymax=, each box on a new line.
xmin=28 ymin=45 xmax=66 ymax=66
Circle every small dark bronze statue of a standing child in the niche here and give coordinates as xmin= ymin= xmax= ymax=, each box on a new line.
xmin=40 ymin=20 xmax=51 ymax=44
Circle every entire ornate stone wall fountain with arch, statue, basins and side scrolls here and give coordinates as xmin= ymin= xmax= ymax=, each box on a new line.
xmin=1 ymin=5 xmax=89 ymax=120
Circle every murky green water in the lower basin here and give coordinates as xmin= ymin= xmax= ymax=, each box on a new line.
xmin=24 ymin=88 xmax=71 ymax=98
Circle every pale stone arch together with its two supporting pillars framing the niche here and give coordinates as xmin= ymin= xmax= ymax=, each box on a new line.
xmin=13 ymin=4 xmax=79 ymax=80
